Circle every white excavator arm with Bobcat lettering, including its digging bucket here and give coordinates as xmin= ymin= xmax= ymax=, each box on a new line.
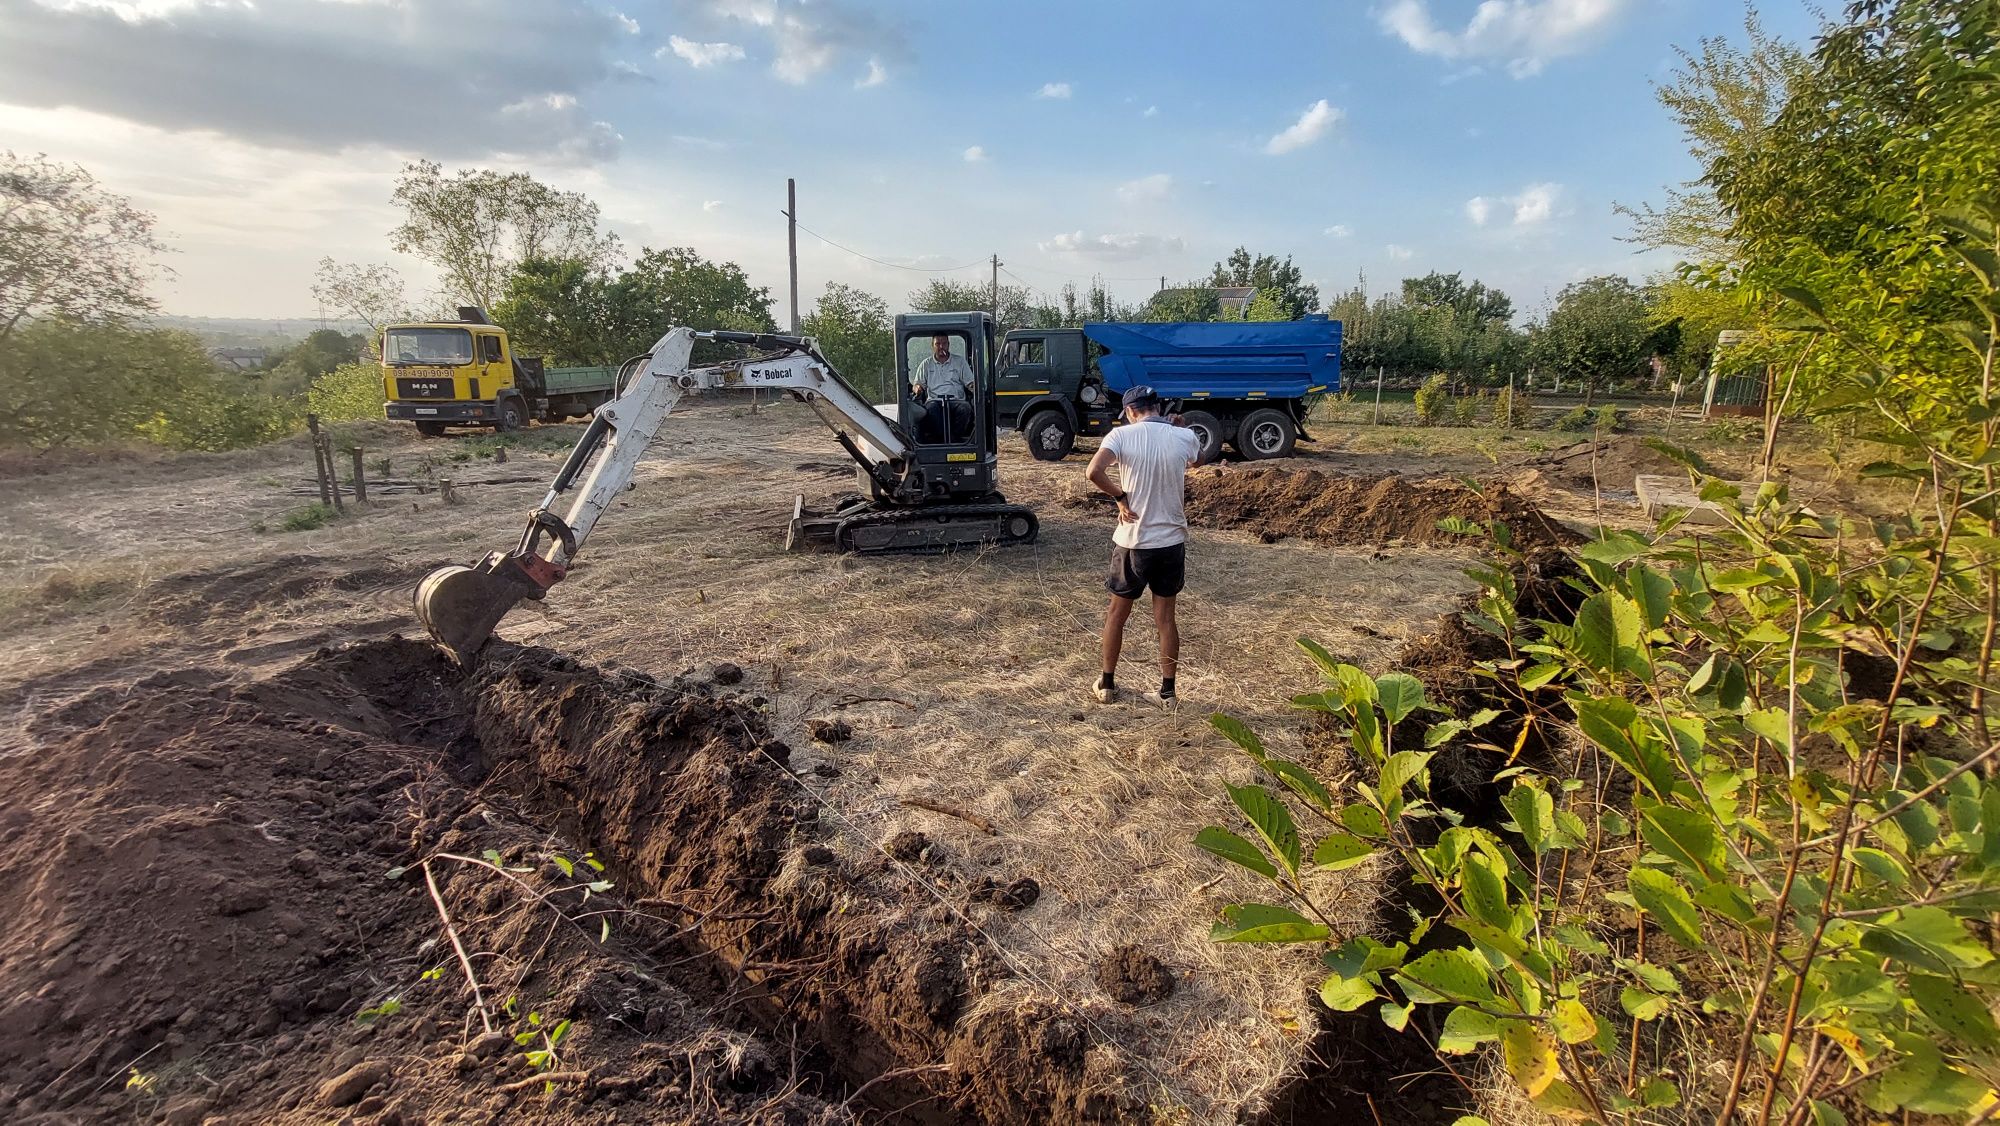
xmin=416 ymin=328 xmax=924 ymax=662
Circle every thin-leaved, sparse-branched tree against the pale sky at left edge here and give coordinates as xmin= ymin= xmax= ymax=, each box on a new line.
xmin=0 ymin=152 xmax=164 ymax=342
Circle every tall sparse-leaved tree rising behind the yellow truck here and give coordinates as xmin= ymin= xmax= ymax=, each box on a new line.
xmin=390 ymin=160 xmax=618 ymax=308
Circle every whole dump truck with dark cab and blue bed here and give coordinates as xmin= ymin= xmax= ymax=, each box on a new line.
xmin=994 ymin=316 xmax=1340 ymax=462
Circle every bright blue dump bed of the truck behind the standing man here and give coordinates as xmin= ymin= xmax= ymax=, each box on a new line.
xmin=1084 ymin=316 xmax=1340 ymax=398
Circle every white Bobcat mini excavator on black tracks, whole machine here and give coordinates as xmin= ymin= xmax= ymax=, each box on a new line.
xmin=416 ymin=312 xmax=1040 ymax=664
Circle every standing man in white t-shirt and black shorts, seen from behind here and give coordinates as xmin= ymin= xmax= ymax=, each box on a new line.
xmin=1088 ymin=386 xmax=1202 ymax=704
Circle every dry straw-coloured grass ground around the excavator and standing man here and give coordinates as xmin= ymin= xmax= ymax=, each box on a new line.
xmin=0 ymin=404 xmax=1592 ymax=1122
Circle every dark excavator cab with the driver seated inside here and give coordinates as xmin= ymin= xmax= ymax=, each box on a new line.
xmin=896 ymin=312 xmax=1000 ymax=502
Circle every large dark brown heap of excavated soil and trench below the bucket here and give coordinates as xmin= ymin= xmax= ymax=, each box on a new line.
xmin=0 ymin=640 xmax=1142 ymax=1126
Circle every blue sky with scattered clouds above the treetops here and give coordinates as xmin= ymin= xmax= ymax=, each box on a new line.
xmin=0 ymin=0 xmax=1816 ymax=324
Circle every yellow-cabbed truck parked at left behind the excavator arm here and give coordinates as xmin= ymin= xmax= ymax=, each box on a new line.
xmin=382 ymin=306 xmax=618 ymax=438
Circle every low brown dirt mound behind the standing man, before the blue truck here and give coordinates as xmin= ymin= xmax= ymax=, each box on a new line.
xmin=1188 ymin=468 xmax=1578 ymax=546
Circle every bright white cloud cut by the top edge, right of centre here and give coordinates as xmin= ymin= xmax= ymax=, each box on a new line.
xmin=1376 ymin=0 xmax=1634 ymax=78
